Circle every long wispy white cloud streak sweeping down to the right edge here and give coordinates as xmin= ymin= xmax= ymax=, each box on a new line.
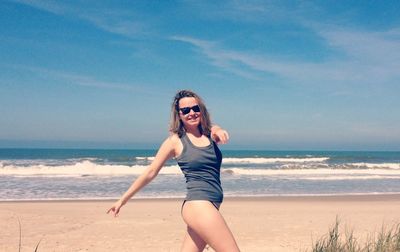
xmin=171 ymin=25 xmax=400 ymax=88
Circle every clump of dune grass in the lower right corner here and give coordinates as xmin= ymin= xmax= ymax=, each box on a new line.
xmin=311 ymin=218 xmax=400 ymax=252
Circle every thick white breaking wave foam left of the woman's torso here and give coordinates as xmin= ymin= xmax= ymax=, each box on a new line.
xmin=0 ymin=160 xmax=181 ymax=177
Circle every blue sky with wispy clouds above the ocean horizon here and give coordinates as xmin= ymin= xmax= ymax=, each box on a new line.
xmin=0 ymin=0 xmax=400 ymax=150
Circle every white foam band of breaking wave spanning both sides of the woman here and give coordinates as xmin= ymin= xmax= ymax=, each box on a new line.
xmin=0 ymin=160 xmax=400 ymax=179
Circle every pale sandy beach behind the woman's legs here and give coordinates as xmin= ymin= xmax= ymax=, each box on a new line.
xmin=0 ymin=195 xmax=400 ymax=252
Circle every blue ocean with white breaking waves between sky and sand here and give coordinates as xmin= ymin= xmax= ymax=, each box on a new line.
xmin=0 ymin=149 xmax=400 ymax=201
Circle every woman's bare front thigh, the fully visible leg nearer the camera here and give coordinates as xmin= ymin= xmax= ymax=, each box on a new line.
xmin=182 ymin=200 xmax=239 ymax=252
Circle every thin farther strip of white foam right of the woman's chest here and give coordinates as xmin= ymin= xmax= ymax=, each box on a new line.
xmin=223 ymin=157 xmax=329 ymax=164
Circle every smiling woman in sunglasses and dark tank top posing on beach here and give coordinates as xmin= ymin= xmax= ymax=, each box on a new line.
xmin=107 ymin=90 xmax=239 ymax=252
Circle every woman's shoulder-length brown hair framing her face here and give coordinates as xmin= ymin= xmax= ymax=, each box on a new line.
xmin=169 ymin=90 xmax=211 ymax=137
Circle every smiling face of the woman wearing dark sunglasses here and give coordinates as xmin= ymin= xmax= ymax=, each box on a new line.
xmin=179 ymin=97 xmax=201 ymax=128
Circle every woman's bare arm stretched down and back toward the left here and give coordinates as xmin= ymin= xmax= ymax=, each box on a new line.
xmin=107 ymin=137 xmax=174 ymax=217
